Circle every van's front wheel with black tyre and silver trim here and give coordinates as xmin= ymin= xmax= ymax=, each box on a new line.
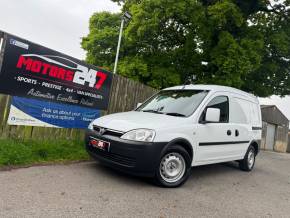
xmin=155 ymin=145 xmax=191 ymax=188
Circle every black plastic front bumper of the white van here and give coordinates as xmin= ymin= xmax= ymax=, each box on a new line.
xmin=85 ymin=130 xmax=167 ymax=177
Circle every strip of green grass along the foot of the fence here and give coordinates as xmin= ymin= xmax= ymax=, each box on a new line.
xmin=0 ymin=139 xmax=89 ymax=167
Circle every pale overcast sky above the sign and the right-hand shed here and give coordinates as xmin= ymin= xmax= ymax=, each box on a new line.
xmin=0 ymin=0 xmax=290 ymax=120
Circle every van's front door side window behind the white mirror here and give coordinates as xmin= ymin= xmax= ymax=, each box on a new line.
xmin=199 ymin=96 xmax=229 ymax=123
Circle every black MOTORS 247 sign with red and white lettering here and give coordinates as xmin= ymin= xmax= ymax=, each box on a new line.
xmin=0 ymin=34 xmax=112 ymax=110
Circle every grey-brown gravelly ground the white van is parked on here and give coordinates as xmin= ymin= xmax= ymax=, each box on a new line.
xmin=0 ymin=152 xmax=290 ymax=217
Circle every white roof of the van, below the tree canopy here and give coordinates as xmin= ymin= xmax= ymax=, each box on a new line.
xmin=163 ymin=84 xmax=258 ymax=102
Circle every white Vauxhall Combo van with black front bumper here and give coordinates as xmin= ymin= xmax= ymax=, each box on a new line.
xmin=86 ymin=85 xmax=262 ymax=187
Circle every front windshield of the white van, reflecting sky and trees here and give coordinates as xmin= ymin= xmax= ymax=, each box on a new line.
xmin=136 ymin=89 xmax=208 ymax=117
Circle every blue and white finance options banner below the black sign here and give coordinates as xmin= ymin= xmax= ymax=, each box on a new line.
xmin=8 ymin=97 xmax=100 ymax=129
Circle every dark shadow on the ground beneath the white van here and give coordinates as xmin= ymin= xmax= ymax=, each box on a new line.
xmin=88 ymin=162 xmax=240 ymax=187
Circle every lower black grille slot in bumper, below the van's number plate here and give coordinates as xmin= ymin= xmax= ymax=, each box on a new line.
xmin=89 ymin=147 xmax=136 ymax=167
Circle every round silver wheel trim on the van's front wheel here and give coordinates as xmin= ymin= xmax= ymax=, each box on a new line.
xmin=159 ymin=152 xmax=186 ymax=183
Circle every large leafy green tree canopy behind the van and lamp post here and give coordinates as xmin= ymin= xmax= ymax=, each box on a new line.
xmin=82 ymin=0 xmax=290 ymax=96
